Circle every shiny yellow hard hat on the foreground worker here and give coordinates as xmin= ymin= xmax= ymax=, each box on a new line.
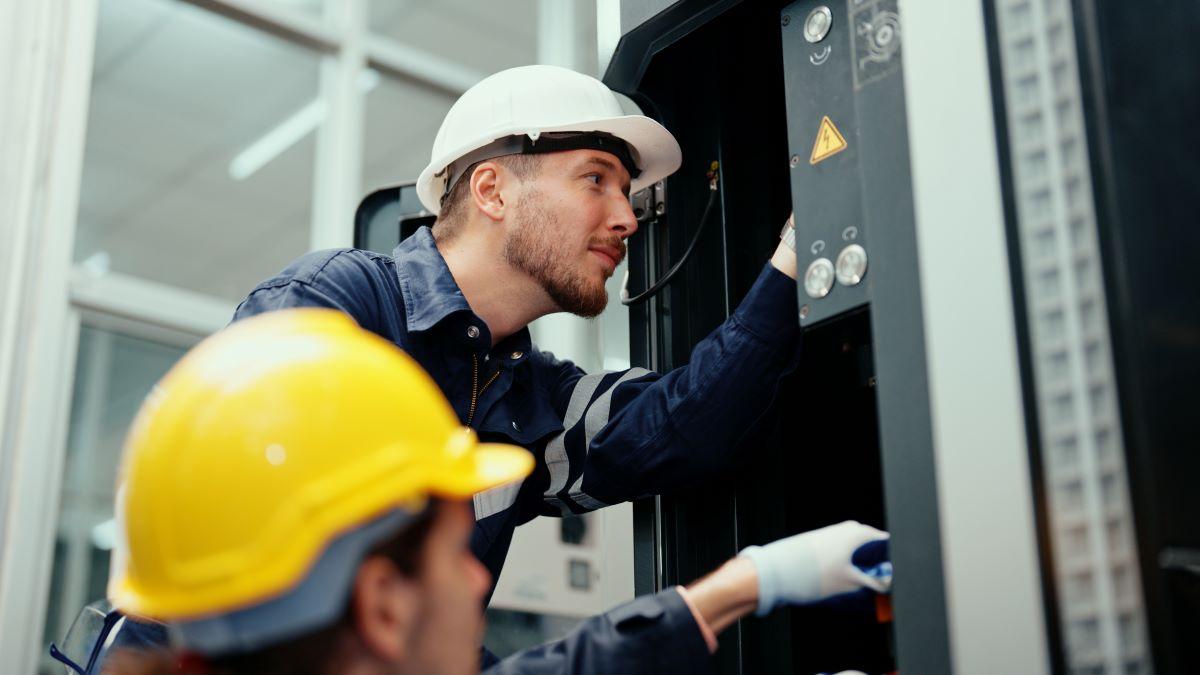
xmin=108 ymin=309 xmax=533 ymax=621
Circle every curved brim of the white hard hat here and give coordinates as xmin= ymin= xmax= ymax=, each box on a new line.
xmin=416 ymin=115 xmax=683 ymax=214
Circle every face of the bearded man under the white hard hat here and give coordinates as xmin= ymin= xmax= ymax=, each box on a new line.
xmin=504 ymin=150 xmax=637 ymax=317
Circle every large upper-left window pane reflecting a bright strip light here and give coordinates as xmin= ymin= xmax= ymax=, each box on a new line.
xmin=74 ymin=0 xmax=320 ymax=299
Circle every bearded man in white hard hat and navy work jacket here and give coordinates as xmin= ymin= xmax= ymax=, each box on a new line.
xmin=225 ymin=66 xmax=799 ymax=662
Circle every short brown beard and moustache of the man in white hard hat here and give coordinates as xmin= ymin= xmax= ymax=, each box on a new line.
xmin=504 ymin=190 xmax=625 ymax=318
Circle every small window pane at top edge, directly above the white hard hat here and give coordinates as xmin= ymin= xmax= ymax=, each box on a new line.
xmin=368 ymin=0 xmax=535 ymax=76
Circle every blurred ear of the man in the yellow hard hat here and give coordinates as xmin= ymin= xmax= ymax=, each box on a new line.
xmin=350 ymin=555 xmax=420 ymax=663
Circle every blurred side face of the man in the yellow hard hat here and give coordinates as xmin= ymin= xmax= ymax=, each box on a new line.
xmin=404 ymin=501 xmax=492 ymax=674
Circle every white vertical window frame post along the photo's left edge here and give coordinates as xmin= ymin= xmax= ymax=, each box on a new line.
xmin=0 ymin=0 xmax=97 ymax=673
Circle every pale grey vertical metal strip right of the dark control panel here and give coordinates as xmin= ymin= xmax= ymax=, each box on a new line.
xmin=900 ymin=0 xmax=1049 ymax=673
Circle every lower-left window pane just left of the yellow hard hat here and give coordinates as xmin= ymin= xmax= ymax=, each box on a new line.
xmin=43 ymin=325 xmax=185 ymax=673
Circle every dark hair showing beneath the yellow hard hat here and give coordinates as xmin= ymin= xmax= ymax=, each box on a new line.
xmin=103 ymin=501 xmax=438 ymax=675
